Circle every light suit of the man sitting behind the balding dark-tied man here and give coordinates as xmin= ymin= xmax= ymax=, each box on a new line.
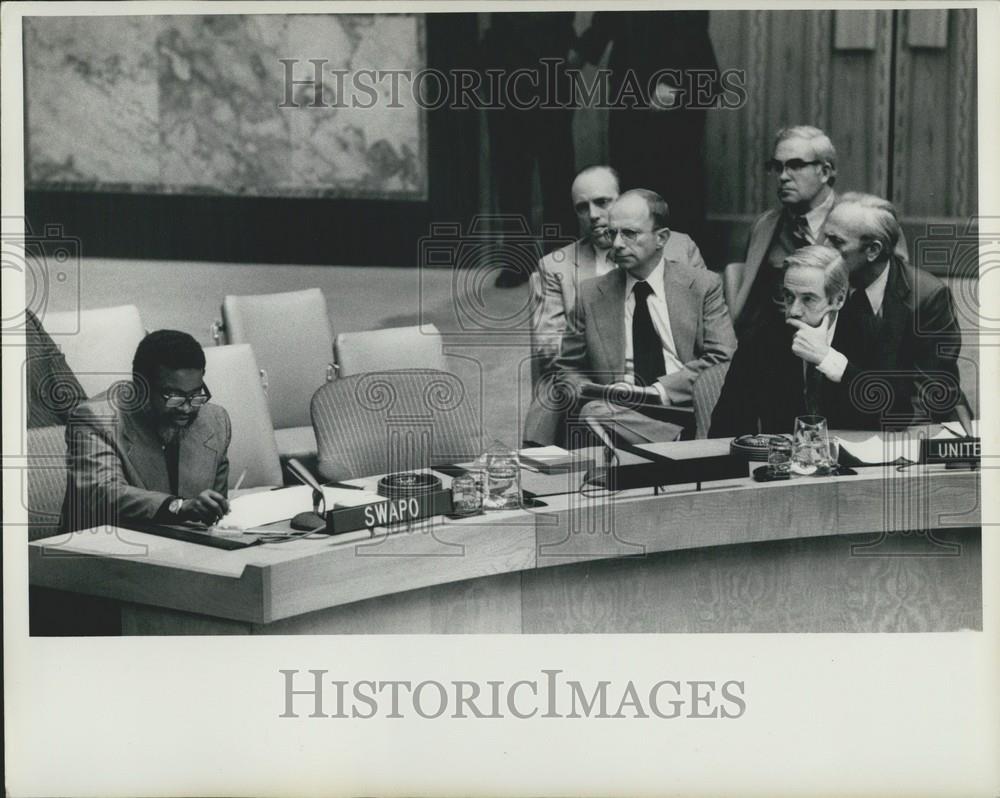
xmin=523 ymin=231 xmax=706 ymax=444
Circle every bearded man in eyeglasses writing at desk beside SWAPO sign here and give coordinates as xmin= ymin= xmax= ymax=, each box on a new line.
xmin=63 ymin=330 xmax=232 ymax=531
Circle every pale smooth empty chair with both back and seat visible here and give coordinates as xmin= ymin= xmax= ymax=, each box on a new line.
xmin=222 ymin=288 xmax=333 ymax=459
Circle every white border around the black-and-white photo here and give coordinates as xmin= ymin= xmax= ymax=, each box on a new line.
xmin=0 ymin=2 xmax=1000 ymax=798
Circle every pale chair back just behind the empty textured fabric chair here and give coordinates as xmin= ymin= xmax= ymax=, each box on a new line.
xmin=334 ymin=324 xmax=447 ymax=377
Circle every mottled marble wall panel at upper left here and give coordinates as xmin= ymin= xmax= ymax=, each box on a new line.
xmin=24 ymin=14 xmax=427 ymax=200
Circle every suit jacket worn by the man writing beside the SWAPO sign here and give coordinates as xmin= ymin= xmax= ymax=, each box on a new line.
xmin=62 ymin=399 xmax=232 ymax=531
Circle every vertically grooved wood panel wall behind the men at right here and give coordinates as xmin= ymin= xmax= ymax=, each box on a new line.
xmin=705 ymin=9 xmax=977 ymax=230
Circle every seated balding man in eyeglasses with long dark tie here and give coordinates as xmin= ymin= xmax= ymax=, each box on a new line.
xmin=556 ymin=189 xmax=736 ymax=443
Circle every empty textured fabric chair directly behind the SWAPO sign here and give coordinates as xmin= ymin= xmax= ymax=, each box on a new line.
xmin=312 ymin=369 xmax=482 ymax=479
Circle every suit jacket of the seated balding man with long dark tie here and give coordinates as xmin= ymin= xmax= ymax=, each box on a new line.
xmin=556 ymin=262 xmax=736 ymax=405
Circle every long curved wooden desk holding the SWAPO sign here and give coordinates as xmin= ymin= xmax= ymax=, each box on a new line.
xmin=29 ymin=442 xmax=982 ymax=634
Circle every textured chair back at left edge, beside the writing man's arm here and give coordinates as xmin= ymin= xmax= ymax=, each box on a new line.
xmin=25 ymin=427 xmax=66 ymax=540
